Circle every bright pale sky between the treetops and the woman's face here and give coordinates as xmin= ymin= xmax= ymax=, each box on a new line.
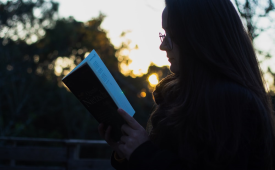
xmin=57 ymin=0 xmax=167 ymax=75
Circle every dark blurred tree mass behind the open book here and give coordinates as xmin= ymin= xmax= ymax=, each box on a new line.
xmin=0 ymin=0 xmax=153 ymax=139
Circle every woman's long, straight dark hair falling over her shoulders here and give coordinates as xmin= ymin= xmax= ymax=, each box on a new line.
xmin=147 ymin=0 xmax=275 ymax=169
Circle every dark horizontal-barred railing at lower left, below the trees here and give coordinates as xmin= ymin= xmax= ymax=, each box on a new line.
xmin=0 ymin=137 xmax=113 ymax=170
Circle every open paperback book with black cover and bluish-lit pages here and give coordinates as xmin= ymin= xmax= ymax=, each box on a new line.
xmin=62 ymin=50 xmax=135 ymax=141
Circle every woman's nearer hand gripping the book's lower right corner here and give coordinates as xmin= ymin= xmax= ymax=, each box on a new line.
xmin=118 ymin=109 xmax=149 ymax=160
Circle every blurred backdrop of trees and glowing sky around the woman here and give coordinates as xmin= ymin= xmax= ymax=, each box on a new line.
xmin=0 ymin=0 xmax=275 ymax=169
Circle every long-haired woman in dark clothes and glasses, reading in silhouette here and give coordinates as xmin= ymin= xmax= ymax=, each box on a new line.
xmin=99 ymin=0 xmax=275 ymax=170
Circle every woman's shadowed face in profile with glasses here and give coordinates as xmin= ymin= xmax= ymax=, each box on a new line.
xmin=159 ymin=7 xmax=180 ymax=73
